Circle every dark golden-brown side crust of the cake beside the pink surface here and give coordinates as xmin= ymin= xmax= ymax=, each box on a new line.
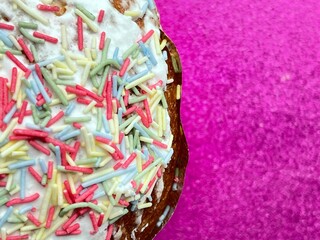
xmin=116 ymin=32 xmax=188 ymax=240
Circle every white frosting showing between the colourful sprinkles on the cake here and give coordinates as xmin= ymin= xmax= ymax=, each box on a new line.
xmin=0 ymin=0 xmax=171 ymax=239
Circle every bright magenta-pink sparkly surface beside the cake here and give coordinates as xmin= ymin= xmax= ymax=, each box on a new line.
xmin=156 ymin=0 xmax=320 ymax=240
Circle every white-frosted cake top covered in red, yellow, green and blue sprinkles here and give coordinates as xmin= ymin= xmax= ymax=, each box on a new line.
xmin=0 ymin=0 xmax=173 ymax=239
